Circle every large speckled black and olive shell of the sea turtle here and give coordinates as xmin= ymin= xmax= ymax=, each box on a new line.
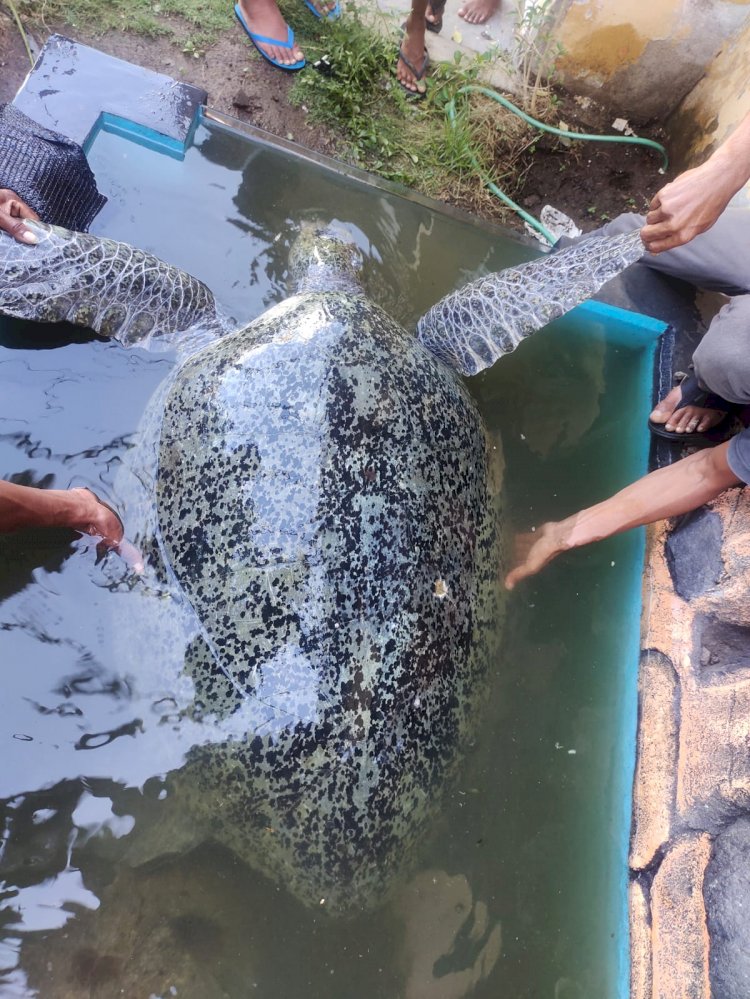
xmin=157 ymin=291 xmax=500 ymax=912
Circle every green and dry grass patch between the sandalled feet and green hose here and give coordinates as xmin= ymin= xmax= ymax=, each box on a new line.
xmin=280 ymin=0 xmax=552 ymax=218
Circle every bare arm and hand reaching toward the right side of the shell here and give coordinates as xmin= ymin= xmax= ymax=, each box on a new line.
xmin=505 ymin=441 xmax=742 ymax=590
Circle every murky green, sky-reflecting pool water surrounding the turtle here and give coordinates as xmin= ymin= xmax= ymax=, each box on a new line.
xmin=0 ymin=119 xmax=651 ymax=999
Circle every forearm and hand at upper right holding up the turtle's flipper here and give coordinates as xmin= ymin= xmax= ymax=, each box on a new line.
xmin=641 ymin=113 xmax=750 ymax=253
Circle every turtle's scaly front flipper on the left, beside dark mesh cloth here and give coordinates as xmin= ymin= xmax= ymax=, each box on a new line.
xmin=0 ymin=222 xmax=222 ymax=346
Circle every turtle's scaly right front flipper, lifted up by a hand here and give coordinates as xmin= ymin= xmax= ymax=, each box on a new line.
xmin=417 ymin=229 xmax=645 ymax=375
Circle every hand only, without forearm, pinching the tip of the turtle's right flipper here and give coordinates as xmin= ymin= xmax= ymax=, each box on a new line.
xmin=641 ymin=160 xmax=736 ymax=253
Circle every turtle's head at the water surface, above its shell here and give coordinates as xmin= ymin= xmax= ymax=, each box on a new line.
xmin=289 ymin=222 xmax=364 ymax=294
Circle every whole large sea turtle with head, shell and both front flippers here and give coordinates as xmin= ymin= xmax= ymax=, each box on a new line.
xmin=0 ymin=219 xmax=641 ymax=911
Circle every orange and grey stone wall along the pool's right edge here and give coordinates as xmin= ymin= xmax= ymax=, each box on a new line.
xmin=630 ymin=489 xmax=750 ymax=999
